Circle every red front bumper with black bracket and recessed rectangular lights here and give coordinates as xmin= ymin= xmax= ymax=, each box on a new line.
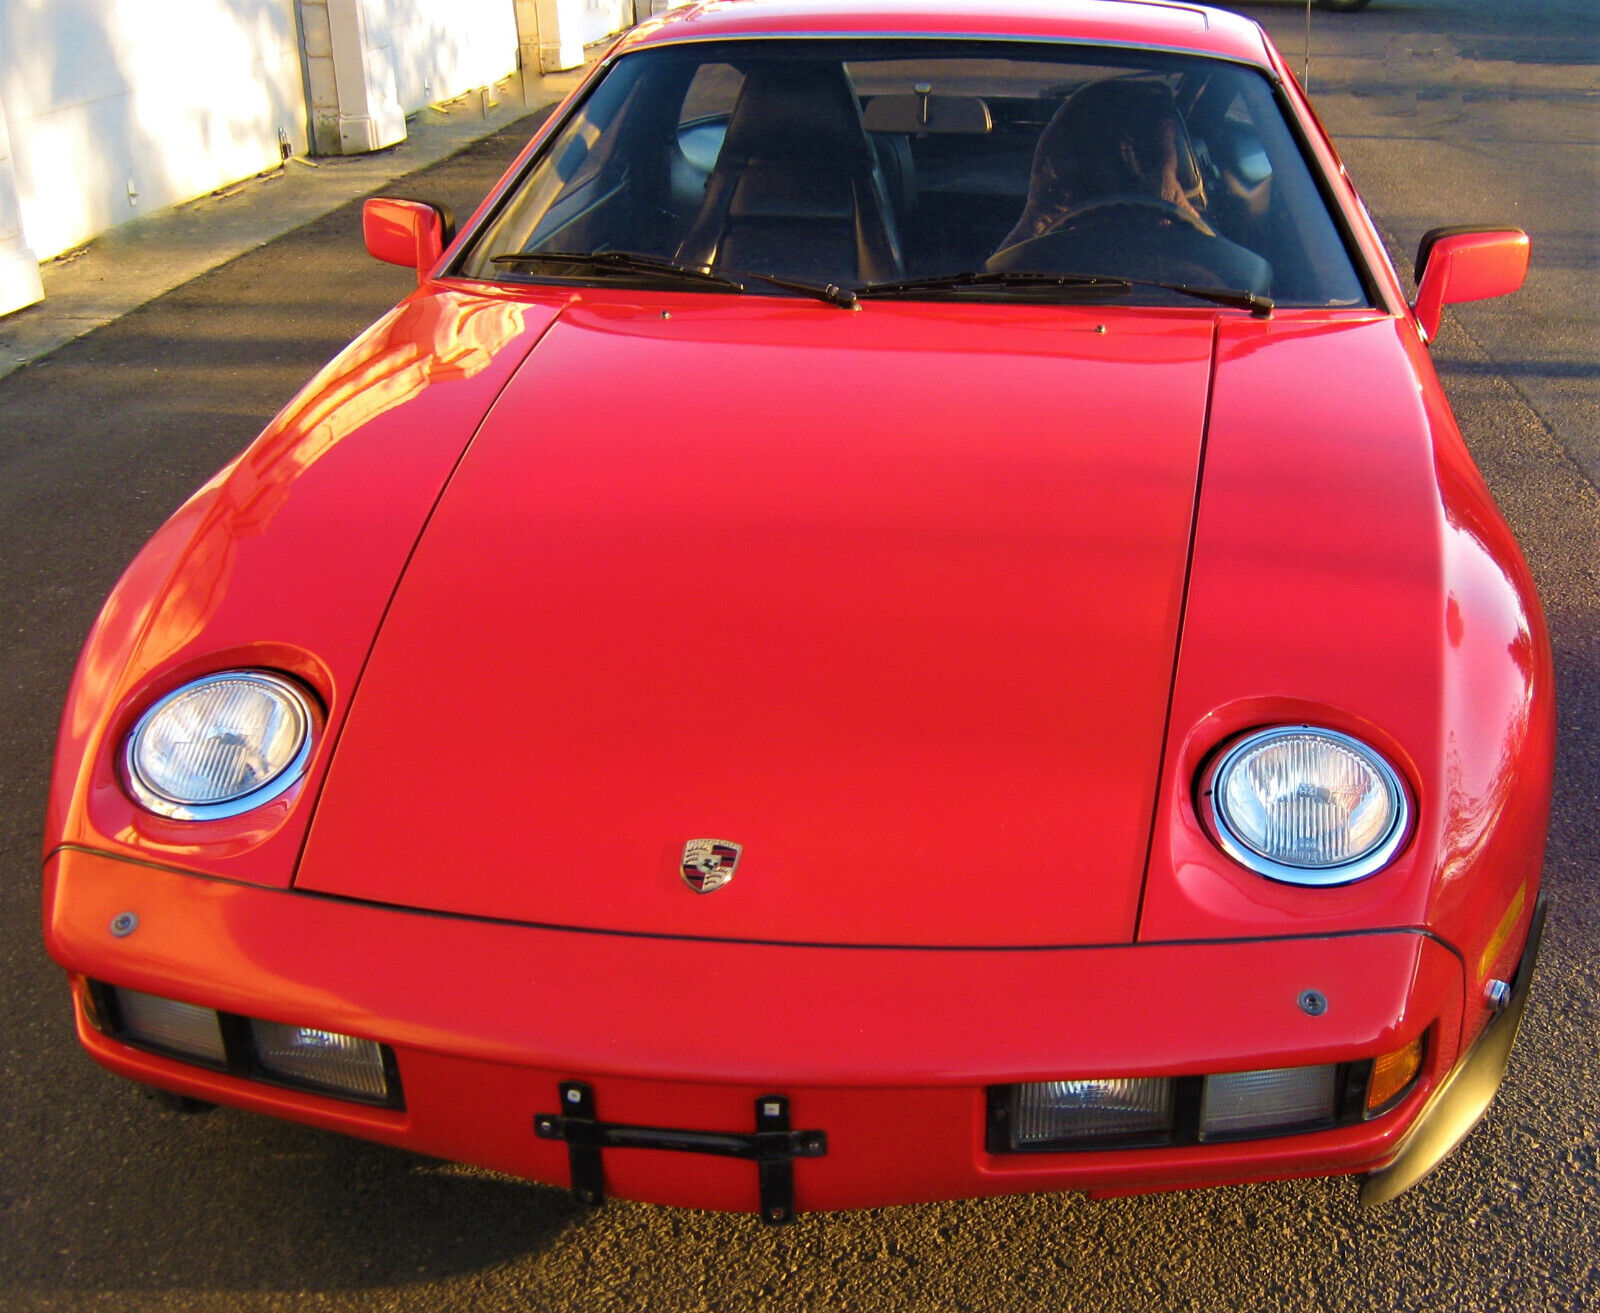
xmin=45 ymin=851 xmax=1464 ymax=1211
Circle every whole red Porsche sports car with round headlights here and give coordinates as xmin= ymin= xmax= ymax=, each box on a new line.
xmin=45 ymin=0 xmax=1554 ymax=1222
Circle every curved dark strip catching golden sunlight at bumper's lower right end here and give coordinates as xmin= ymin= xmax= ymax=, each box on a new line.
xmin=1360 ymin=894 xmax=1549 ymax=1207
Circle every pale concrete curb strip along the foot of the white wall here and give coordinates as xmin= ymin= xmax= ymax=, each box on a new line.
xmin=0 ymin=69 xmax=584 ymax=379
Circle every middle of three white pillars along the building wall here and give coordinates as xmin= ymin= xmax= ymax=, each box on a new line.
xmin=299 ymin=0 xmax=405 ymax=155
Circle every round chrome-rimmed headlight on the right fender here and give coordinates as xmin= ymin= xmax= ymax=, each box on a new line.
xmin=1202 ymin=726 xmax=1408 ymax=884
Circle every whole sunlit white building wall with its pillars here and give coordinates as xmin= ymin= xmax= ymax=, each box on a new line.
xmin=0 ymin=0 xmax=624 ymax=302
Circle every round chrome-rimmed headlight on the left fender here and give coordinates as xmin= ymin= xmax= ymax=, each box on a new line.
xmin=123 ymin=670 xmax=312 ymax=820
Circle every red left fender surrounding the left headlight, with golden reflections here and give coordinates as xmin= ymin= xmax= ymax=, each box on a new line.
xmin=45 ymin=289 xmax=566 ymax=886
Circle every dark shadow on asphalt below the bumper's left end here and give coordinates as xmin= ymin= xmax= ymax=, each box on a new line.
xmin=12 ymin=1078 xmax=586 ymax=1307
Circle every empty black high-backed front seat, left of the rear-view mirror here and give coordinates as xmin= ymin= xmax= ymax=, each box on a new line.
xmin=677 ymin=61 xmax=901 ymax=286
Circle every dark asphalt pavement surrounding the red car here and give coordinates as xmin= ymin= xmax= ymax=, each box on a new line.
xmin=0 ymin=0 xmax=1600 ymax=1313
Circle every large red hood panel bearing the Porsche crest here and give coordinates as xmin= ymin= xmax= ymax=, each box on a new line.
xmin=296 ymin=297 xmax=1213 ymax=945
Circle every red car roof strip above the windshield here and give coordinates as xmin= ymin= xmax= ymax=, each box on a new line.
xmin=622 ymin=0 xmax=1269 ymax=67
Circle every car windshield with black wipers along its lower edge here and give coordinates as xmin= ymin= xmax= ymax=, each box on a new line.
xmin=454 ymin=38 xmax=1368 ymax=305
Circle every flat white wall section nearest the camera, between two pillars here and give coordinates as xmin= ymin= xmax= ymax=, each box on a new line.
xmin=0 ymin=0 xmax=306 ymax=259
